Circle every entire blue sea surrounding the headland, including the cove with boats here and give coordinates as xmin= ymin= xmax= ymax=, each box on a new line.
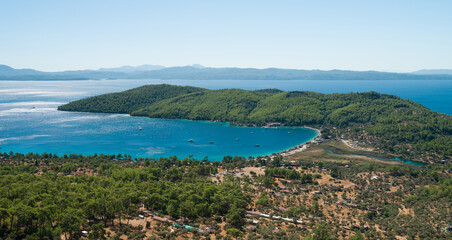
xmin=0 ymin=79 xmax=452 ymax=161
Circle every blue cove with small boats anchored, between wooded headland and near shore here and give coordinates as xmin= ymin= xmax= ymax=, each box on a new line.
xmin=0 ymin=108 xmax=317 ymax=161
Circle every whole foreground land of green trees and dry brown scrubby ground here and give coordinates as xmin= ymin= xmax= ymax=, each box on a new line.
xmin=0 ymin=152 xmax=452 ymax=239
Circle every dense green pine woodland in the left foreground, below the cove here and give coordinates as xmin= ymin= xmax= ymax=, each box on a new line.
xmin=0 ymin=154 xmax=250 ymax=239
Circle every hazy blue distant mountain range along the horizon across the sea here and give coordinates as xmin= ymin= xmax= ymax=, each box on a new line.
xmin=0 ymin=64 xmax=452 ymax=80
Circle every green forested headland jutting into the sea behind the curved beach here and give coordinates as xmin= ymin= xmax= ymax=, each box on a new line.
xmin=59 ymin=85 xmax=452 ymax=158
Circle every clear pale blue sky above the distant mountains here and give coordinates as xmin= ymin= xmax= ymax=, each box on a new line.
xmin=0 ymin=0 xmax=452 ymax=72
